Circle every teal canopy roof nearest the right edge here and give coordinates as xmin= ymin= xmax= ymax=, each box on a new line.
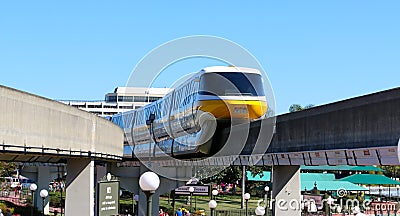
xmin=339 ymin=174 xmax=400 ymax=185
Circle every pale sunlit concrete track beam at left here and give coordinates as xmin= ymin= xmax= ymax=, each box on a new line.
xmin=0 ymin=85 xmax=124 ymax=162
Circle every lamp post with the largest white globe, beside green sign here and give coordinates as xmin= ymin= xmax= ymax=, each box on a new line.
xmin=139 ymin=172 xmax=160 ymax=216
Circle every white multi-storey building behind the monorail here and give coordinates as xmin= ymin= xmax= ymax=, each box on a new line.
xmin=60 ymin=87 xmax=171 ymax=117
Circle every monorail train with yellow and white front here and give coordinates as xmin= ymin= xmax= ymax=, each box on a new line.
xmin=111 ymin=66 xmax=268 ymax=158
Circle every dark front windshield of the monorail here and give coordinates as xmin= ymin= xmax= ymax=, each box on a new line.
xmin=199 ymin=72 xmax=265 ymax=96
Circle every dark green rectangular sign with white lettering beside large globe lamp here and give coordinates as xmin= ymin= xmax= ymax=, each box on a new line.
xmin=97 ymin=181 xmax=119 ymax=216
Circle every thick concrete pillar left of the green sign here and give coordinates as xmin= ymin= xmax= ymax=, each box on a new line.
xmin=65 ymin=158 xmax=94 ymax=216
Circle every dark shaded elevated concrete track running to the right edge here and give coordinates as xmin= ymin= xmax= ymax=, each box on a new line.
xmin=120 ymin=88 xmax=400 ymax=166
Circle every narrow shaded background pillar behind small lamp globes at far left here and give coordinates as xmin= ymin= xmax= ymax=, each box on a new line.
xmin=34 ymin=166 xmax=51 ymax=215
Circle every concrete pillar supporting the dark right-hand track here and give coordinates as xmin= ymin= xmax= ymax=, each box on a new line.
xmin=272 ymin=166 xmax=301 ymax=216
